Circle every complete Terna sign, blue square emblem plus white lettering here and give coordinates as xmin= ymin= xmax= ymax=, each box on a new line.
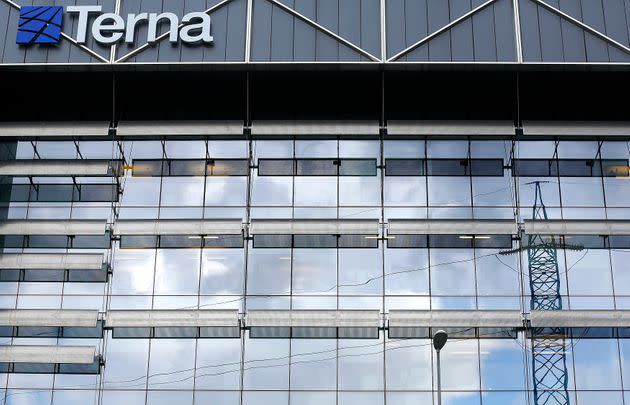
xmin=16 ymin=6 xmax=213 ymax=45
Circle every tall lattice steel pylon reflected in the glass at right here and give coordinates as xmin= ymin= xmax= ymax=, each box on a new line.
xmin=527 ymin=182 xmax=569 ymax=405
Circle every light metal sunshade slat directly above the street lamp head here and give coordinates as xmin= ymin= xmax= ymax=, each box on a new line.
xmin=388 ymin=310 xmax=523 ymax=328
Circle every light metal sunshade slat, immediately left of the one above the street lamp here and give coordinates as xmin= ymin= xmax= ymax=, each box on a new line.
xmin=245 ymin=310 xmax=381 ymax=328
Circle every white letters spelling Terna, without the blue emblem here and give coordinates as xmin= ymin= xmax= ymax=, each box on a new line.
xmin=66 ymin=6 xmax=213 ymax=44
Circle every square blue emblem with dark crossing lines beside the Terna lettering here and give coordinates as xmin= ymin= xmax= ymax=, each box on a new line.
xmin=15 ymin=6 xmax=63 ymax=44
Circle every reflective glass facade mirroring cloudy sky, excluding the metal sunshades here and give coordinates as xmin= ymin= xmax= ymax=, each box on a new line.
xmin=0 ymin=136 xmax=630 ymax=405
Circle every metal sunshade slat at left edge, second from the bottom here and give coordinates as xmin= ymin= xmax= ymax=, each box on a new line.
xmin=0 ymin=309 xmax=98 ymax=328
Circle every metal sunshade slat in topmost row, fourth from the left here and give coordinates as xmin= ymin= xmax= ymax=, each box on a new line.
xmin=387 ymin=121 xmax=515 ymax=136
